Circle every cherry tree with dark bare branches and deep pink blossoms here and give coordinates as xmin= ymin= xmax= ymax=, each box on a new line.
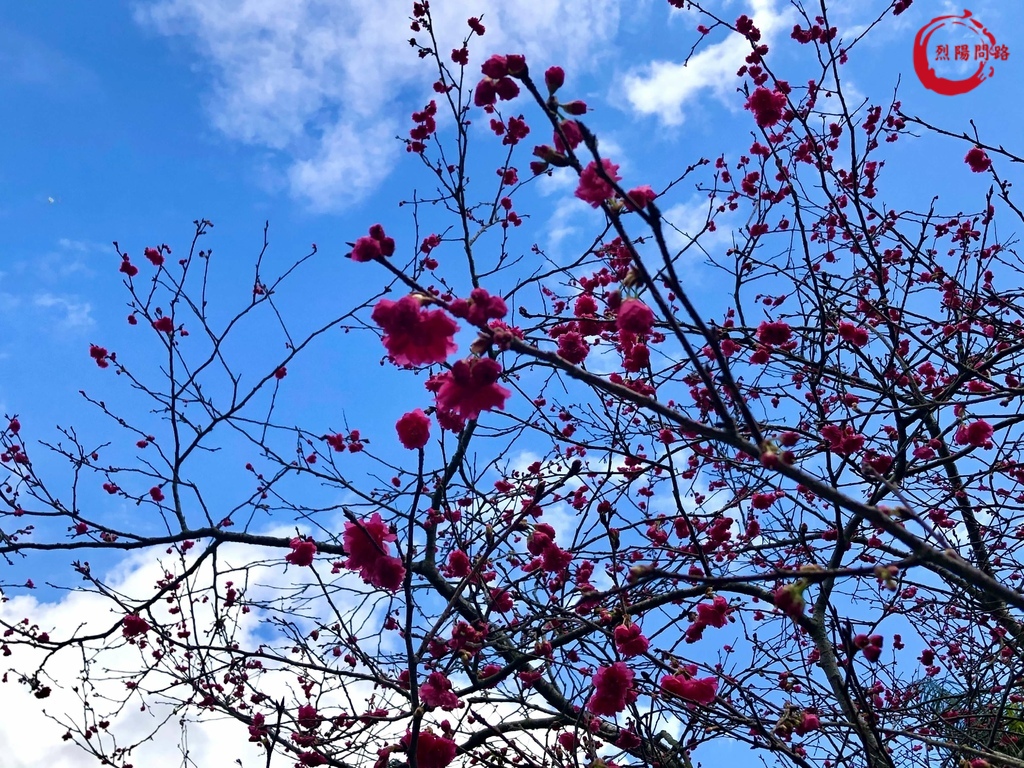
xmin=0 ymin=0 xmax=1024 ymax=768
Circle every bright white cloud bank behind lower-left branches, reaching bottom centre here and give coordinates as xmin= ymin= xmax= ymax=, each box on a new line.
xmin=0 ymin=518 xmax=606 ymax=768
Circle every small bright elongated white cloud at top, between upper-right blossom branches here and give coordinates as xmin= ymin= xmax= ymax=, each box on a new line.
xmin=623 ymin=0 xmax=794 ymax=125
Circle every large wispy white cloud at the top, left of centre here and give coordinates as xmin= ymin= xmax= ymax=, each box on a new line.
xmin=136 ymin=0 xmax=620 ymax=210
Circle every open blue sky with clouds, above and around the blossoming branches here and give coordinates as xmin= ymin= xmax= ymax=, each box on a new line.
xmin=0 ymin=0 xmax=1024 ymax=768
